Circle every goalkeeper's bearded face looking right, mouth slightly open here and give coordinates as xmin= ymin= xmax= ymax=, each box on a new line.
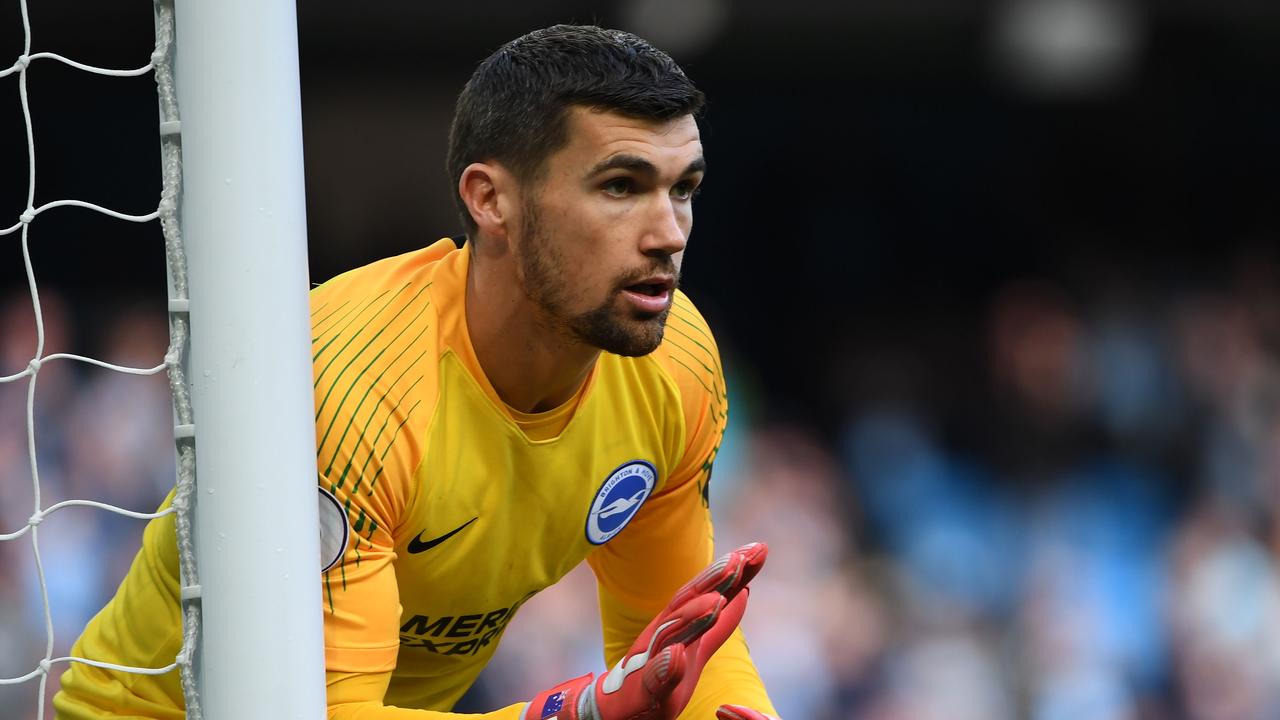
xmin=513 ymin=108 xmax=704 ymax=356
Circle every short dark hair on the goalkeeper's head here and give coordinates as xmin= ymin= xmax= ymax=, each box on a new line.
xmin=447 ymin=24 xmax=703 ymax=234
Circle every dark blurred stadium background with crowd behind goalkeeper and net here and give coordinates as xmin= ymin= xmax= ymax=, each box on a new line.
xmin=0 ymin=0 xmax=1280 ymax=720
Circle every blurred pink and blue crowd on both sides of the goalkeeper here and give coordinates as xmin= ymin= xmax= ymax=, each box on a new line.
xmin=0 ymin=242 xmax=1280 ymax=720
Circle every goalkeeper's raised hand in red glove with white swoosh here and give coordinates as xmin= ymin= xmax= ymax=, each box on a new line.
xmin=522 ymin=543 xmax=769 ymax=720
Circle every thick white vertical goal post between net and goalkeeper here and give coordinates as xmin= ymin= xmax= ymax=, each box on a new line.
xmin=174 ymin=0 xmax=326 ymax=720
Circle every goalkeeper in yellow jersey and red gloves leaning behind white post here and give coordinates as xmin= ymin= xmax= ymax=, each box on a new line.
xmin=55 ymin=26 xmax=774 ymax=720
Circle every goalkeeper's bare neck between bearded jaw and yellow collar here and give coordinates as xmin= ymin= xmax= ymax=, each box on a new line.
xmin=465 ymin=245 xmax=600 ymax=413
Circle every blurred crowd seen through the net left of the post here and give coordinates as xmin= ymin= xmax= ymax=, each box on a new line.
xmin=0 ymin=288 xmax=174 ymax=720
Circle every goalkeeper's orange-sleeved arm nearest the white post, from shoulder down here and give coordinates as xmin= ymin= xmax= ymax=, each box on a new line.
xmin=311 ymin=256 xmax=444 ymax=717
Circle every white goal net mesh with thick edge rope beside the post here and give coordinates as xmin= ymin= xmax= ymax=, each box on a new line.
xmin=0 ymin=0 xmax=201 ymax=720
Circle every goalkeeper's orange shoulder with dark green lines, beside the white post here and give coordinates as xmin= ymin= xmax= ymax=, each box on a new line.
xmin=311 ymin=238 xmax=457 ymax=509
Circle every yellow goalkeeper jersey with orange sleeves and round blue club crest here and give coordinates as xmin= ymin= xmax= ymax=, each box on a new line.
xmin=54 ymin=238 xmax=773 ymax=720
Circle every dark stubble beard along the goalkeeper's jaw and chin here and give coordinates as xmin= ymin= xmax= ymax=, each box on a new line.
xmin=517 ymin=202 xmax=669 ymax=357
